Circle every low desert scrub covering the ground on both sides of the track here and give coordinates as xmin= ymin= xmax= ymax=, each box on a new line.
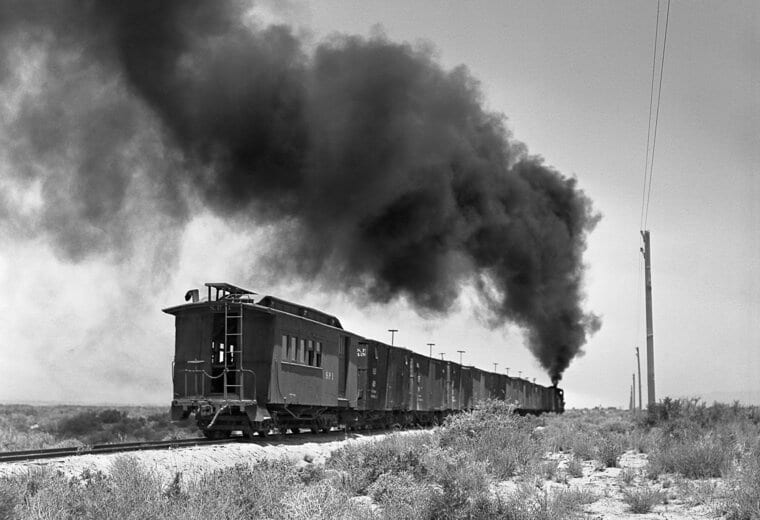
xmin=0 ymin=399 xmax=760 ymax=520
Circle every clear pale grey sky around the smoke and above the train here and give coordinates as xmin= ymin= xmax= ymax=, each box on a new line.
xmin=0 ymin=1 xmax=760 ymax=407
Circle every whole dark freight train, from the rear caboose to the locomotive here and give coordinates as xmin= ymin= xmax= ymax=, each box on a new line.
xmin=164 ymin=283 xmax=564 ymax=438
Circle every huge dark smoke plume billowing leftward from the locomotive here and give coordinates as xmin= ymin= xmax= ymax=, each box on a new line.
xmin=0 ymin=0 xmax=598 ymax=381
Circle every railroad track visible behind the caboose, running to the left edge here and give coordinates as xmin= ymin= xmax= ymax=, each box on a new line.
xmin=0 ymin=437 xmax=240 ymax=463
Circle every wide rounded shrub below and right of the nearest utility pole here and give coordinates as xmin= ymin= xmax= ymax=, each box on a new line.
xmin=647 ymin=435 xmax=734 ymax=478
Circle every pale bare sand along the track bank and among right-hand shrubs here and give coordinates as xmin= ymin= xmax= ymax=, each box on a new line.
xmin=0 ymin=431 xmax=720 ymax=520
